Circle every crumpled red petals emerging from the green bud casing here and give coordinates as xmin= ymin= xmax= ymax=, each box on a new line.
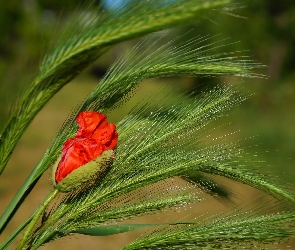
xmin=55 ymin=111 xmax=118 ymax=183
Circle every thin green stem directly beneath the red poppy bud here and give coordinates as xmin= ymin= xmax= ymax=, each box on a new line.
xmin=16 ymin=189 xmax=59 ymax=250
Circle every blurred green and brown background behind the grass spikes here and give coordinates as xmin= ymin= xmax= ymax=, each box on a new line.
xmin=0 ymin=0 xmax=295 ymax=249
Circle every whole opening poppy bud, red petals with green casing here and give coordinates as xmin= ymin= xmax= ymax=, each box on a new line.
xmin=53 ymin=111 xmax=118 ymax=192
